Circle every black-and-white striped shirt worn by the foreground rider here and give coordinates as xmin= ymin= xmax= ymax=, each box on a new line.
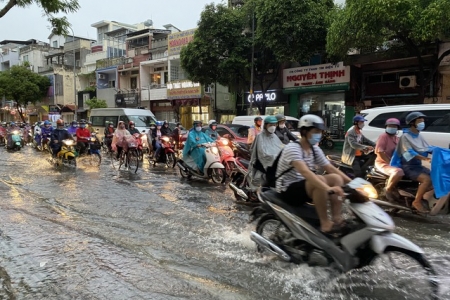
xmin=276 ymin=143 xmax=330 ymax=193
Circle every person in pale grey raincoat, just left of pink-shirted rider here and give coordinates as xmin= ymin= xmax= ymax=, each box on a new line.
xmin=341 ymin=115 xmax=375 ymax=177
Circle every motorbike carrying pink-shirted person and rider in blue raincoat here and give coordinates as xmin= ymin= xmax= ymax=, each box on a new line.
xmin=367 ymin=167 xmax=450 ymax=216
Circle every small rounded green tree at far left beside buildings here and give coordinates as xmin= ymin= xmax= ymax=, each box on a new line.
xmin=0 ymin=66 xmax=50 ymax=122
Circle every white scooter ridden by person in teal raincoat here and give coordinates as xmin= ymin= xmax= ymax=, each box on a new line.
xmin=177 ymin=143 xmax=226 ymax=183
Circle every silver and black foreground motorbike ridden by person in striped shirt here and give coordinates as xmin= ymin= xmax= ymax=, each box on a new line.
xmin=250 ymin=178 xmax=438 ymax=295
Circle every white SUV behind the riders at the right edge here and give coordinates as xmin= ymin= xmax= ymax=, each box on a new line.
xmin=361 ymin=104 xmax=450 ymax=148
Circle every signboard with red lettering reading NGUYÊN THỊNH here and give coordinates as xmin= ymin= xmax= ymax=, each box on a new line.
xmin=283 ymin=62 xmax=350 ymax=93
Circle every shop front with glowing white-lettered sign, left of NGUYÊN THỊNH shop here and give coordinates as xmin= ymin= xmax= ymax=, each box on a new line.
xmin=236 ymin=89 xmax=290 ymax=116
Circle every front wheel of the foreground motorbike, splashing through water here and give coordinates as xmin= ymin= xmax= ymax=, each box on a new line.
xmin=360 ymin=246 xmax=439 ymax=299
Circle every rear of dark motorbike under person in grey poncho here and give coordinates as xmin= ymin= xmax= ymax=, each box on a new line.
xmin=229 ymin=157 xmax=259 ymax=204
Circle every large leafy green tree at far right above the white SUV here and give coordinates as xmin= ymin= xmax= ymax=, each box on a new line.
xmin=327 ymin=0 xmax=450 ymax=100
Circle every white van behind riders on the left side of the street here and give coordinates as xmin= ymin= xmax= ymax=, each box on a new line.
xmin=90 ymin=108 xmax=156 ymax=137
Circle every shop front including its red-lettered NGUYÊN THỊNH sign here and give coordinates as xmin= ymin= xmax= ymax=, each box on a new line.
xmin=283 ymin=62 xmax=353 ymax=139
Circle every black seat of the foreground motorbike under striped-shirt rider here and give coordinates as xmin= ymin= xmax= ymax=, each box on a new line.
xmin=261 ymin=189 xmax=320 ymax=227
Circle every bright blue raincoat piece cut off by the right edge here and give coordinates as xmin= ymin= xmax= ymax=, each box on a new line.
xmin=431 ymin=147 xmax=450 ymax=199
